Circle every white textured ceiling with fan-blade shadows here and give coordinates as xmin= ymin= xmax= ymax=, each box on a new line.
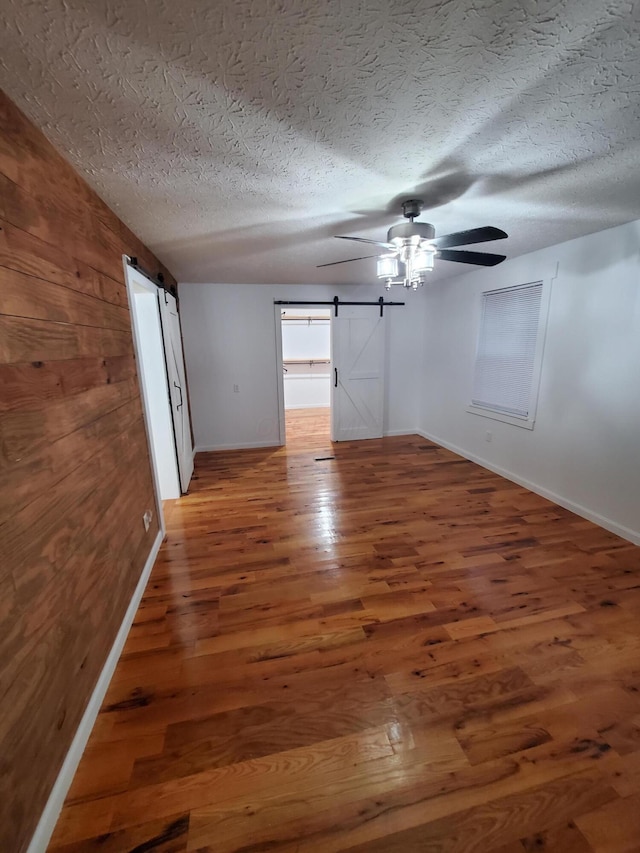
xmin=0 ymin=0 xmax=640 ymax=283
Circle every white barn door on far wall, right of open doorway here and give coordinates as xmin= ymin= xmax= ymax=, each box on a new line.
xmin=331 ymin=305 xmax=386 ymax=441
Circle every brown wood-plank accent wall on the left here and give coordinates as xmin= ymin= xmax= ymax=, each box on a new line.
xmin=0 ymin=88 xmax=174 ymax=853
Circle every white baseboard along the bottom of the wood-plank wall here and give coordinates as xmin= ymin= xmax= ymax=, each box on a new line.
xmin=27 ymin=530 xmax=164 ymax=853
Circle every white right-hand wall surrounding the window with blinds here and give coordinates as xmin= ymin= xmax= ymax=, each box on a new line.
xmin=420 ymin=216 xmax=640 ymax=542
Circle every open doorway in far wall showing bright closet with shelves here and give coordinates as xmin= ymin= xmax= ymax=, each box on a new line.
xmin=280 ymin=305 xmax=331 ymax=447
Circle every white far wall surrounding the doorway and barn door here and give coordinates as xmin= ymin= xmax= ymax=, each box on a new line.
xmin=180 ymin=284 xmax=423 ymax=450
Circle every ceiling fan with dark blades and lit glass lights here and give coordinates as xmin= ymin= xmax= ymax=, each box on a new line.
xmin=318 ymin=198 xmax=508 ymax=290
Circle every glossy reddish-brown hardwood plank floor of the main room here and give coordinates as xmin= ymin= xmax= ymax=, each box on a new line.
xmin=50 ymin=416 xmax=640 ymax=853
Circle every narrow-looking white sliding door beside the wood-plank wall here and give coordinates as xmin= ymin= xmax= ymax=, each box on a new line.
xmin=159 ymin=290 xmax=193 ymax=493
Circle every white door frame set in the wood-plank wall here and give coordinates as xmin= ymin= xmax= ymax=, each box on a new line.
xmin=123 ymin=255 xmax=180 ymax=520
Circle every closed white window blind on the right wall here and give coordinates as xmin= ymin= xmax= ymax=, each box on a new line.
xmin=471 ymin=281 xmax=542 ymax=418
